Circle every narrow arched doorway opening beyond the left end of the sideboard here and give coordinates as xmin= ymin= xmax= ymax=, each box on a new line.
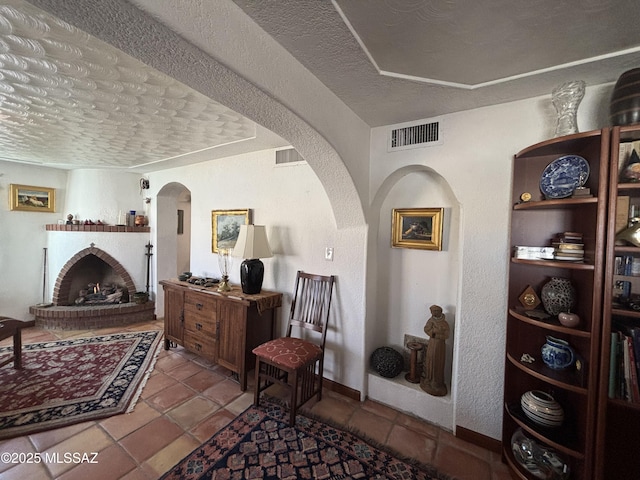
xmin=156 ymin=182 xmax=191 ymax=317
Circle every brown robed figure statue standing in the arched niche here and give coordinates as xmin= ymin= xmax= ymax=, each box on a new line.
xmin=420 ymin=305 xmax=449 ymax=397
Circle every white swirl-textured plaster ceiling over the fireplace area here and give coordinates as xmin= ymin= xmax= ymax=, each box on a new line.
xmin=0 ymin=1 xmax=280 ymax=169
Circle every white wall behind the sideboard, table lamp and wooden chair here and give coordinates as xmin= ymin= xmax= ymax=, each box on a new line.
xmin=149 ymin=150 xmax=366 ymax=390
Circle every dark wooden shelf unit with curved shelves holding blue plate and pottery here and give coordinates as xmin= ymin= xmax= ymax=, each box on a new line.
xmin=502 ymin=129 xmax=608 ymax=480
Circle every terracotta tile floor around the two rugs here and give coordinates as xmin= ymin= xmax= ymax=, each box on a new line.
xmin=0 ymin=321 xmax=510 ymax=480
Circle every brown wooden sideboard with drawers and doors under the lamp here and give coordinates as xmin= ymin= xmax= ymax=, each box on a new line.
xmin=160 ymin=280 xmax=282 ymax=391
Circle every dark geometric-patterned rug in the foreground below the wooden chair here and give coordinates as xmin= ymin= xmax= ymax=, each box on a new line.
xmin=162 ymin=400 xmax=450 ymax=480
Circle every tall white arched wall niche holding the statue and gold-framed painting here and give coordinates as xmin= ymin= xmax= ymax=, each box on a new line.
xmin=366 ymin=165 xmax=461 ymax=430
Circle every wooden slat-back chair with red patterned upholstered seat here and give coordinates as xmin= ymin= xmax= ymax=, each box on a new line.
xmin=253 ymin=271 xmax=335 ymax=426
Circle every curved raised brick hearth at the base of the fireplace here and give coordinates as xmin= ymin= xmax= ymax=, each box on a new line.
xmin=29 ymin=302 xmax=155 ymax=330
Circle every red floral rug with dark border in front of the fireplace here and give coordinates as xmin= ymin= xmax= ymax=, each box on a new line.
xmin=0 ymin=331 xmax=162 ymax=439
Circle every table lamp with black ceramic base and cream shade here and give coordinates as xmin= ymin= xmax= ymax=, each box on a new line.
xmin=232 ymin=225 xmax=273 ymax=295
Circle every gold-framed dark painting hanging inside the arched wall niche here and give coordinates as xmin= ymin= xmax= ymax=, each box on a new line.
xmin=391 ymin=208 xmax=444 ymax=250
